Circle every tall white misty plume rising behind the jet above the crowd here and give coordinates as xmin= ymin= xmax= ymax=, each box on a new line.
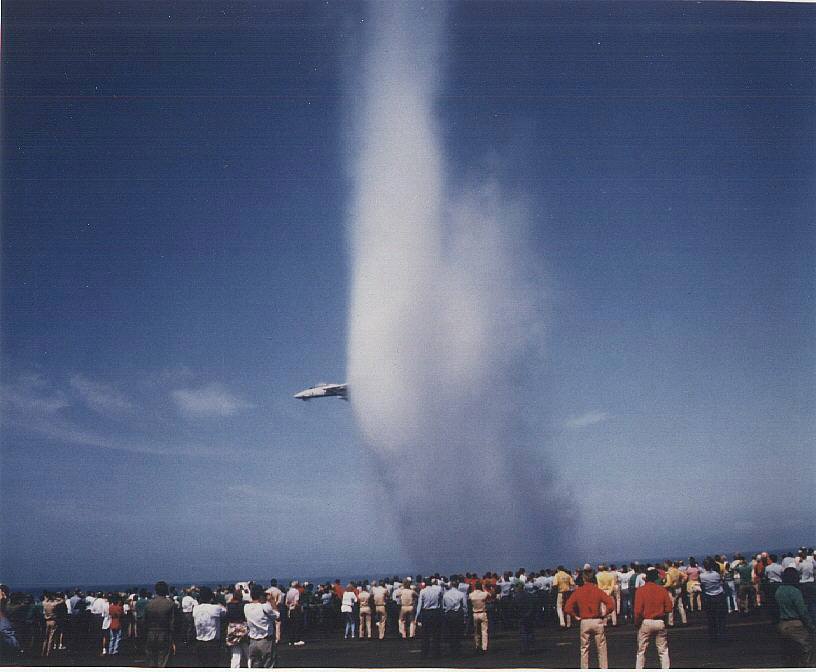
xmin=348 ymin=3 xmax=566 ymax=569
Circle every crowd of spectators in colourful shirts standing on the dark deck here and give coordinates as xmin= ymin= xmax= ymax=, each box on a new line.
xmin=0 ymin=548 xmax=816 ymax=669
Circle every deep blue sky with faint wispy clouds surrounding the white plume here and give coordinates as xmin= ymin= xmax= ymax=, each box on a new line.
xmin=0 ymin=2 xmax=816 ymax=584
